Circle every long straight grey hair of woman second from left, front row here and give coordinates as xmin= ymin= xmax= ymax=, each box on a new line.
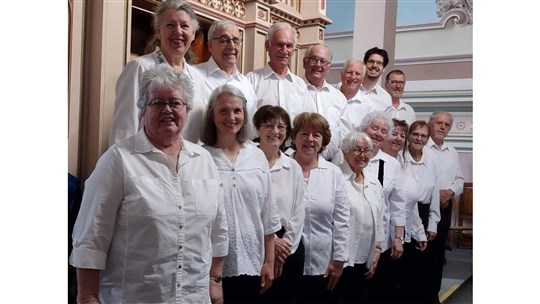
xmin=201 ymin=84 xmax=251 ymax=146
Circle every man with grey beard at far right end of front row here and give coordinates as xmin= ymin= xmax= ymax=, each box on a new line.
xmin=425 ymin=112 xmax=465 ymax=301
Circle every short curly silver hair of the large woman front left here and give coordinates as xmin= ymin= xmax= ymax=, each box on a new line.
xmin=137 ymin=63 xmax=194 ymax=111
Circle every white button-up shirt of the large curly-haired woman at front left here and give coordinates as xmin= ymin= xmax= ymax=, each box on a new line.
xmin=70 ymin=129 xmax=228 ymax=303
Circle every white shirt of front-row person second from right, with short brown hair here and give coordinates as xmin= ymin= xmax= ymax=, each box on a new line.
xmin=404 ymin=148 xmax=441 ymax=233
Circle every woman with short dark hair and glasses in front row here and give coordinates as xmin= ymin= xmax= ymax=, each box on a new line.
xmin=253 ymin=105 xmax=305 ymax=303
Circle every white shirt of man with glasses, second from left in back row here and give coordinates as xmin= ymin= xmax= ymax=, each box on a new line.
xmin=194 ymin=57 xmax=257 ymax=121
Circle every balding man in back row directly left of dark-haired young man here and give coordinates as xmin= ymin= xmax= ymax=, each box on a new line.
xmin=338 ymin=59 xmax=385 ymax=144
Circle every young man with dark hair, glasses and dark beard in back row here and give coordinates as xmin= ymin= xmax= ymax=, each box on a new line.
xmin=360 ymin=47 xmax=392 ymax=109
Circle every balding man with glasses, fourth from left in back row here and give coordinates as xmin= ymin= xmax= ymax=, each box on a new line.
xmin=304 ymin=44 xmax=347 ymax=161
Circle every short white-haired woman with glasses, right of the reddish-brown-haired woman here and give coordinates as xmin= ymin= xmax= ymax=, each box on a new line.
xmin=337 ymin=131 xmax=384 ymax=303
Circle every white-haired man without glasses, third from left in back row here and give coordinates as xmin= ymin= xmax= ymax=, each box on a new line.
xmin=246 ymin=22 xmax=317 ymax=121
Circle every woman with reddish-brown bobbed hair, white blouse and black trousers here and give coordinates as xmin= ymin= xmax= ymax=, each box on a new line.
xmin=291 ymin=112 xmax=350 ymax=303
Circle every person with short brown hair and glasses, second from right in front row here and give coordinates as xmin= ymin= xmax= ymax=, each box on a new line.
xmin=402 ymin=120 xmax=441 ymax=303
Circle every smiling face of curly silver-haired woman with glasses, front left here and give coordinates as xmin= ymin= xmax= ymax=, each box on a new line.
xmin=143 ymin=88 xmax=188 ymax=142
